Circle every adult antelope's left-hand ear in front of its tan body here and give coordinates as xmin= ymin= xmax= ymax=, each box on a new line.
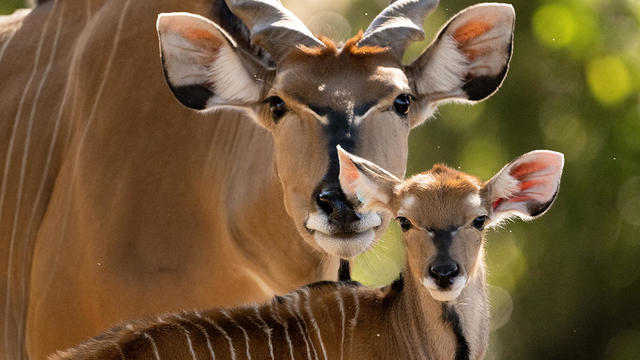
xmin=156 ymin=13 xmax=264 ymax=110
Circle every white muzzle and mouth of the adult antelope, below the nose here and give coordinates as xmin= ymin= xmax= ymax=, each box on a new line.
xmin=305 ymin=212 xmax=382 ymax=259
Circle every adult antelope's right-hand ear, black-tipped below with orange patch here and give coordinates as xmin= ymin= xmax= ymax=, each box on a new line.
xmin=409 ymin=3 xmax=515 ymax=103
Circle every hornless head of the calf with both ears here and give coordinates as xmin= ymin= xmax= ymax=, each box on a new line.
xmin=339 ymin=146 xmax=564 ymax=301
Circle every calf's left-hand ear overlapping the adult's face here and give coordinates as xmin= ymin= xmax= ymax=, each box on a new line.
xmin=337 ymin=145 xmax=401 ymax=211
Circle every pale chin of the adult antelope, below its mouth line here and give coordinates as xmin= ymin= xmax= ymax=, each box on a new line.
xmin=313 ymin=229 xmax=376 ymax=259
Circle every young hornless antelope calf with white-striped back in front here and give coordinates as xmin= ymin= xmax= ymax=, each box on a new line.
xmin=52 ymin=147 xmax=564 ymax=360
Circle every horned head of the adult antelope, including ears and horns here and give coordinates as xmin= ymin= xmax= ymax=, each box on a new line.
xmin=157 ymin=0 xmax=515 ymax=258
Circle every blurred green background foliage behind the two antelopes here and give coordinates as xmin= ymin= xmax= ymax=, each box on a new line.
xmin=0 ymin=0 xmax=640 ymax=360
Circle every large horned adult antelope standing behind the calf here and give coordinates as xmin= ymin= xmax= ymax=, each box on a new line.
xmin=0 ymin=0 xmax=514 ymax=359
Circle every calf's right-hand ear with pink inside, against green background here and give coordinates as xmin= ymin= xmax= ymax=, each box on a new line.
xmin=484 ymin=150 xmax=564 ymax=224
